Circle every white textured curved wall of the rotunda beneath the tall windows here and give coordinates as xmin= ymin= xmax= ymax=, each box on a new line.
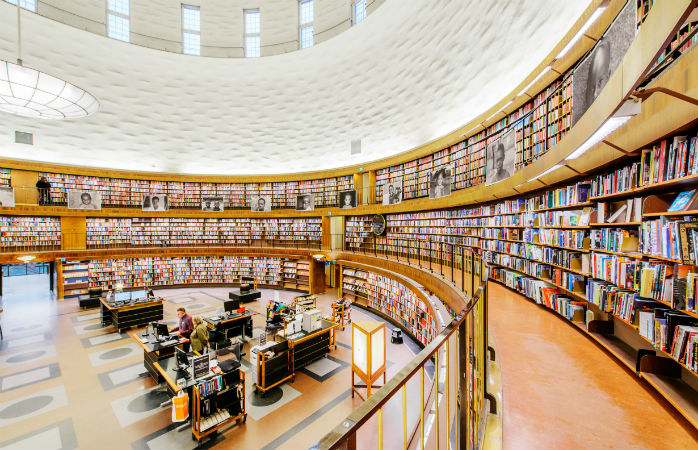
xmin=0 ymin=0 xmax=589 ymax=174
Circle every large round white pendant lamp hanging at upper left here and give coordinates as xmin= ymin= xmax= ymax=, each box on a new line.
xmin=0 ymin=60 xmax=99 ymax=120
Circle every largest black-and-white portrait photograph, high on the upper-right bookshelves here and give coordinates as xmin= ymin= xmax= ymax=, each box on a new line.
xmin=572 ymin=2 xmax=635 ymax=125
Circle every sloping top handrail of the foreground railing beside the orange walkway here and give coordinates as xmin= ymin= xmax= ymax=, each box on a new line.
xmin=316 ymin=285 xmax=485 ymax=449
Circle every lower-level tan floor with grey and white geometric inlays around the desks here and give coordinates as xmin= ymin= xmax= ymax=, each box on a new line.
xmin=0 ymin=275 xmax=418 ymax=450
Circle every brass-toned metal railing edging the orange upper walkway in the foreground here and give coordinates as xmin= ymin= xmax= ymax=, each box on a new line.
xmin=314 ymin=250 xmax=496 ymax=450
